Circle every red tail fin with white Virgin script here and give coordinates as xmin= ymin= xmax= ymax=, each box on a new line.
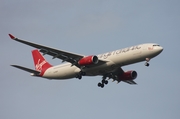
xmin=32 ymin=50 xmax=52 ymax=75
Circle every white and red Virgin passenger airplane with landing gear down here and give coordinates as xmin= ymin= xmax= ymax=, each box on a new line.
xmin=9 ymin=34 xmax=163 ymax=88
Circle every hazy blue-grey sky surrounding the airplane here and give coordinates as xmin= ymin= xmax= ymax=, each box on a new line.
xmin=0 ymin=0 xmax=180 ymax=119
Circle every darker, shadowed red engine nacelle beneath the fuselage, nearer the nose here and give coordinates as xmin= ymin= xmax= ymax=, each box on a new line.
xmin=120 ymin=70 xmax=137 ymax=80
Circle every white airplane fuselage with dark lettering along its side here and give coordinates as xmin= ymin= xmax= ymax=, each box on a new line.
xmin=42 ymin=43 xmax=163 ymax=79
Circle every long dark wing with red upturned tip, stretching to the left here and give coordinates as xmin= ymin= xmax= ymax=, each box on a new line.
xmin=9 ymin=34 xmax=105 ymax=68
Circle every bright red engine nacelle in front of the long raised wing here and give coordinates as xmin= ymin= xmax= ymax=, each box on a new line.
xmin=78 ymin=55 xmax=99 ymax=66
